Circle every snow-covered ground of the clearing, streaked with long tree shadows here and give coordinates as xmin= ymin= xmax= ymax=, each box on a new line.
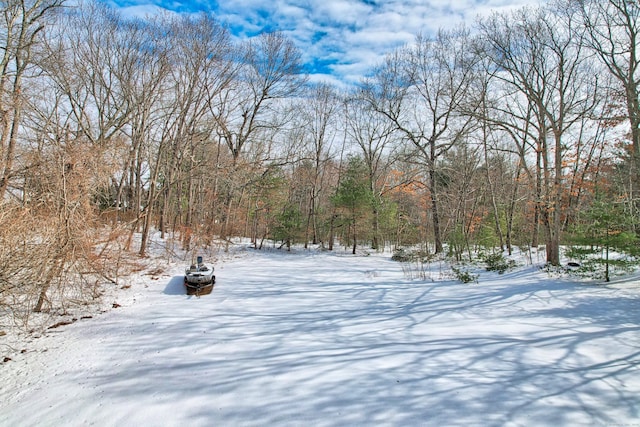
xmin=0 ymin=244 xmax=640 ymax=427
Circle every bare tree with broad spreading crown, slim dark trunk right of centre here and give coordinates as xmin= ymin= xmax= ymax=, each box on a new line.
xmin=364 ymin=30 xmax=476 ymax=252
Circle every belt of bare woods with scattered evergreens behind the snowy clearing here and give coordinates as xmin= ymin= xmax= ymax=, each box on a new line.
xmin=0 ymin=0 xmax=640 ymax=326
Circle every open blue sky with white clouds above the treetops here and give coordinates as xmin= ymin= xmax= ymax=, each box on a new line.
xmin=112 ymin=0 xmax=539 ymax=85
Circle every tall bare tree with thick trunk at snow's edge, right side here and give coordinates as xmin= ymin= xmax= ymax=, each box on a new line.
xmin=480 ymin=2 xmax=598 ymax=265
